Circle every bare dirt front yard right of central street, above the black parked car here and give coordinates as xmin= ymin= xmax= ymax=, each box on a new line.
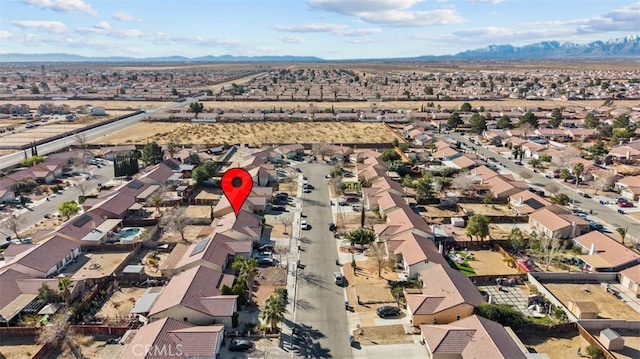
xmin=344 ymin=261 xmax=398 ymax=312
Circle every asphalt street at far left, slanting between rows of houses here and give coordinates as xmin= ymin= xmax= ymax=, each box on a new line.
xmin=0 ymin=161 xmax=113 ymax=243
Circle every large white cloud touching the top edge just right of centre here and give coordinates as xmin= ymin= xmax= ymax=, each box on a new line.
xmin=308 ymin=0 xmax=466 ymax=27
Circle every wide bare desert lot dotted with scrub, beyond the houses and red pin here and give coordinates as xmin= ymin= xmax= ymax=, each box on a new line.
xmin=93 ymin=122 xmax=395 ymax=145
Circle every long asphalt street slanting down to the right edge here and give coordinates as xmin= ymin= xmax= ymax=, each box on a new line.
xmin=439 ymin=133 xmax=640 ymax=238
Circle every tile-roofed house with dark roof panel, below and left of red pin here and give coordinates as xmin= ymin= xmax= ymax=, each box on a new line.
xmin=160 ymin=232 xmax=253 ymax=277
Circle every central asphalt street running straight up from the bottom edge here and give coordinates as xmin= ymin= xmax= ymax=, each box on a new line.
xmin=294 ymin=163 xmax=351 ymax=358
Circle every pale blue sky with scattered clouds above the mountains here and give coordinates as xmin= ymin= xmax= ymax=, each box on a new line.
xmin=0 ymin=0 xmax=640 ymax=60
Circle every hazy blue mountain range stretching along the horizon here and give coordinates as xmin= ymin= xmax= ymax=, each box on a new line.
xmin=0 ymin=35 xmax=640 ymax=63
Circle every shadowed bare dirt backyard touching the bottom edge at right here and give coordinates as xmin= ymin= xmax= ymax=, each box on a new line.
xmin=518 ymin=331 xmax=589 ymax=359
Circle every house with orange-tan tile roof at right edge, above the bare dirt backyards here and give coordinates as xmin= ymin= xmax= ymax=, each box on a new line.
xmin=573 ymin=231 xmax=640 ymax=272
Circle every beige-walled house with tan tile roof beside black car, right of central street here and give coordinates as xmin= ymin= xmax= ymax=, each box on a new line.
xmin=405 ymin=263 xmax=485 ymax=327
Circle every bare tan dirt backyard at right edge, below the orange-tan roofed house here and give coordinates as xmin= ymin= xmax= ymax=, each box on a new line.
xmin=544 ymin=283 xmax=640 ymax=320
